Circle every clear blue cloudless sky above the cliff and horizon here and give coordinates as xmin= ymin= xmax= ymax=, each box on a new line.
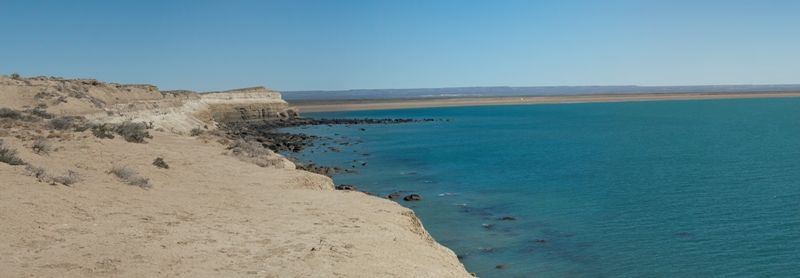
xmin=0 ymin=0 xmax=800 ymax=91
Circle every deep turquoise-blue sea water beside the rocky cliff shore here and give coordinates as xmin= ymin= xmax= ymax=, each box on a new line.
xmin=280 ymin=98 xmax=800 ymax=277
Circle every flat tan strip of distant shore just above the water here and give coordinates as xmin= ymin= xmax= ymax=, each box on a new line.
xmin=289 ymin=91 xmax=800 ymax=112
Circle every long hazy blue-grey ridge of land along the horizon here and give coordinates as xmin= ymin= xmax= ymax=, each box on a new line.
xmin=283 ymin=84 xmax=800 ymax=101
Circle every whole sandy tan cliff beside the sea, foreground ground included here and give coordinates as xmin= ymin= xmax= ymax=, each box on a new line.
xmin=0 ymin=75 xmax=469 ymax=277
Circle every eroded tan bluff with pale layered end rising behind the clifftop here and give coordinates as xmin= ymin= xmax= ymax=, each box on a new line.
xmin=0 ymin=77 xmax=297 ymax=133
